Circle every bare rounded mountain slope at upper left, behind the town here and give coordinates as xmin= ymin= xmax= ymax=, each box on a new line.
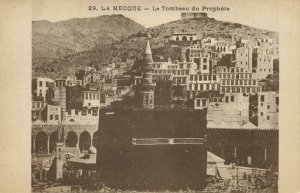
xmin=32 ymin=15 xmax=144 ymax=76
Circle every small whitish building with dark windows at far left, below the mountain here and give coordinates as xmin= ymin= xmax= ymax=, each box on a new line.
xmin=32 ymin=77 xmax=53 ymax=101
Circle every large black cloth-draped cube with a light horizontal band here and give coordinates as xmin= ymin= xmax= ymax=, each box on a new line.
xmin=97 ymin=108 xmax=207 ymax=191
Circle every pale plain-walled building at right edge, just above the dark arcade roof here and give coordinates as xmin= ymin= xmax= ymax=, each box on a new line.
xmin=257 ymin=92 xmax=279 ymax=128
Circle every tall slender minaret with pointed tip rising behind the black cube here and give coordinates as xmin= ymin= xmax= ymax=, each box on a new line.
xmin=140 ymin=40 xmax=155 ymax=109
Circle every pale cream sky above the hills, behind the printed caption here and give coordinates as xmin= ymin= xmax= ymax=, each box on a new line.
xmin=32 ymin=0 xmax=279 ymax=31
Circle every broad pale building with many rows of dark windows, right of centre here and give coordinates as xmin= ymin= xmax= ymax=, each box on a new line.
xmin=217 ymin=67 xmax=261 ymax=94
